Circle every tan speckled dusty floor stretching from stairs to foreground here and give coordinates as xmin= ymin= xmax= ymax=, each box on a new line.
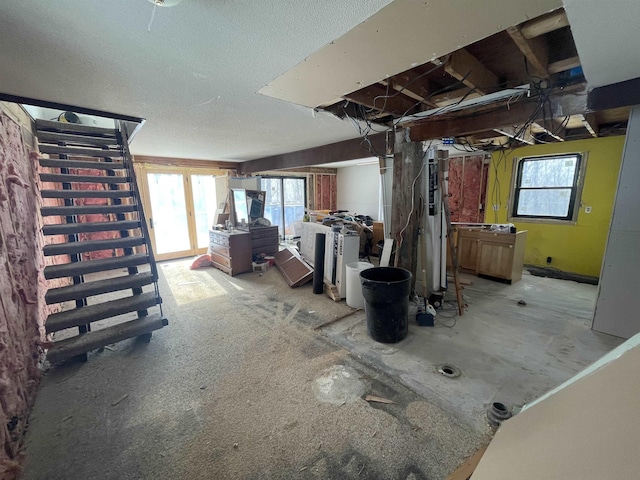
xmin=23 ymin=261 xmax=488 ymax=480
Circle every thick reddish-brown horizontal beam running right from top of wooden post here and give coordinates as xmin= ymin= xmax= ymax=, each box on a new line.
xmin=409 ymin=84 xmax=586 ymax=141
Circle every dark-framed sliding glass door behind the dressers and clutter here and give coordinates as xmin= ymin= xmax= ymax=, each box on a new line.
xmin=261 ymin=177 xmax=307 ymax=238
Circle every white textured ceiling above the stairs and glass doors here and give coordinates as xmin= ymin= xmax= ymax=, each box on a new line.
xmin=0 ymin=0 xmax=389 ymax=160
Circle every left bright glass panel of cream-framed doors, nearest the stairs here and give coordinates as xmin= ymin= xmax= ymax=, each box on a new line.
xmin=147 ymin=173 xmax=191 ymax=258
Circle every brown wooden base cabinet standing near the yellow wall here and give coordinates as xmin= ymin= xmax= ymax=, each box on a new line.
xmin=458 ymin=228 xmax=527 ymax=283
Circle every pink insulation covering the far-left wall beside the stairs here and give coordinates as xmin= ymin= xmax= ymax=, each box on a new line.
xmin=0 ymin=112 xmax=66 ymax=479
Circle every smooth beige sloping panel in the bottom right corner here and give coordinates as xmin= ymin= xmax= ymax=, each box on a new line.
xmin=471 ymin=346 xmax=640 ymax=480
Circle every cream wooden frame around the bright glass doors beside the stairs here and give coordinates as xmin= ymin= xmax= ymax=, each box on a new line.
xmin=134 ymin=163 xmax=229 ymax=261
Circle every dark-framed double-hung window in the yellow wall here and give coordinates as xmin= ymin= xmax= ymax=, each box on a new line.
xmin=511 ymin=153 xmax=582 ymax=221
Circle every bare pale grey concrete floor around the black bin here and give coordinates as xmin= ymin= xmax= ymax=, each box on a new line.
xmin=323 ymin=272 xmax=623 ymax=432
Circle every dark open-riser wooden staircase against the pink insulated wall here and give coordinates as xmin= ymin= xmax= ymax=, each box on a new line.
xmin=36 ymin=120 xmax=168 ymax=363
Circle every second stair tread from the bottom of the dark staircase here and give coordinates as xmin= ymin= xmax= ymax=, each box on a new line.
xmin=45 ymin=292 xmax=161 ymax=333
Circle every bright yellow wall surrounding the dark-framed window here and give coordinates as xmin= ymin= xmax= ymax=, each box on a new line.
xmin=485 ymin=136 xmax=624 ymax=277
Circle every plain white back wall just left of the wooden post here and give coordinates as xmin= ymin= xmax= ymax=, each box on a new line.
xmin=337 ymin=162 xmax=380 ymax=220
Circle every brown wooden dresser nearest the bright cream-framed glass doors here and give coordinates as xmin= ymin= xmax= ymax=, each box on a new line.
xmin=209 ymin=230 xmax=252 ymax=277
